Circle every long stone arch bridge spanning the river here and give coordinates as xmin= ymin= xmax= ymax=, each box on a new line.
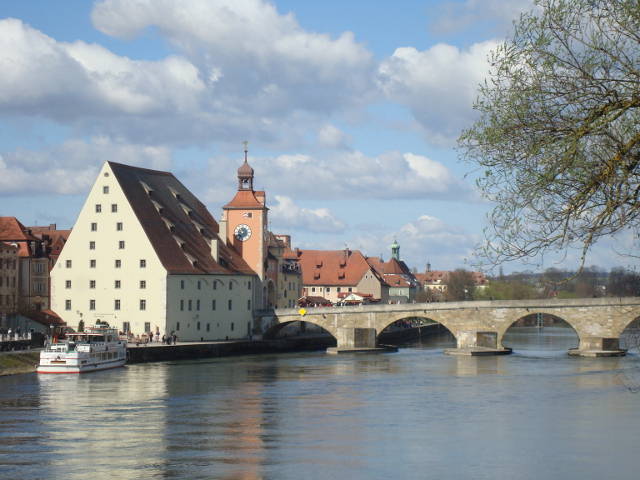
xmin=254 ymin=297 xmax=640 ymax=356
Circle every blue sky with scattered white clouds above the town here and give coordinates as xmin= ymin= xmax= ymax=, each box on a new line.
xmin=0 ymin=0 xmax=629 ymax=272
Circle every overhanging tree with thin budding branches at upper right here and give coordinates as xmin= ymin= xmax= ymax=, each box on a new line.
xmin=458 ymin=0 xmax=640 ymax=274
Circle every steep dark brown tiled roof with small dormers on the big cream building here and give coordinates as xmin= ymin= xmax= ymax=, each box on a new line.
xmin=108 ymin=162 xmax=254 ymax=275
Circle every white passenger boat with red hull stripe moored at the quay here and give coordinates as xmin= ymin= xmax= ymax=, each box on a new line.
xmin=36 ymin=324 xmax=128 ymax=373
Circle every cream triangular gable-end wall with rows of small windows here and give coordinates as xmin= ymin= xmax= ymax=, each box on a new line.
xmin=51 ymin=163 xmax=167 ymax=335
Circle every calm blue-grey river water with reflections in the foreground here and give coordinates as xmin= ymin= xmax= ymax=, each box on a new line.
xmin=0 ymin=327 xmax=640 ymax=480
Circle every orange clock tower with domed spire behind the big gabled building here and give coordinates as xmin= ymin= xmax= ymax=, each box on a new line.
xmin=220 ymin=142 xmax=269 ymax=304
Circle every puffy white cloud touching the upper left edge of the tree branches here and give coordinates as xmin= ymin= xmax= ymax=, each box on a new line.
xmin=378 ymin=41 xmax=498 ymax=146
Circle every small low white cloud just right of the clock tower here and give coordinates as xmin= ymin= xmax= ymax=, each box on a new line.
xmin=269 ymin=195 xmax=347 ymax=234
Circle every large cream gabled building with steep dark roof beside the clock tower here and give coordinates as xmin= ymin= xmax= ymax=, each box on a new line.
xmin=51 ymin=162 xmax=262 ymax=341
